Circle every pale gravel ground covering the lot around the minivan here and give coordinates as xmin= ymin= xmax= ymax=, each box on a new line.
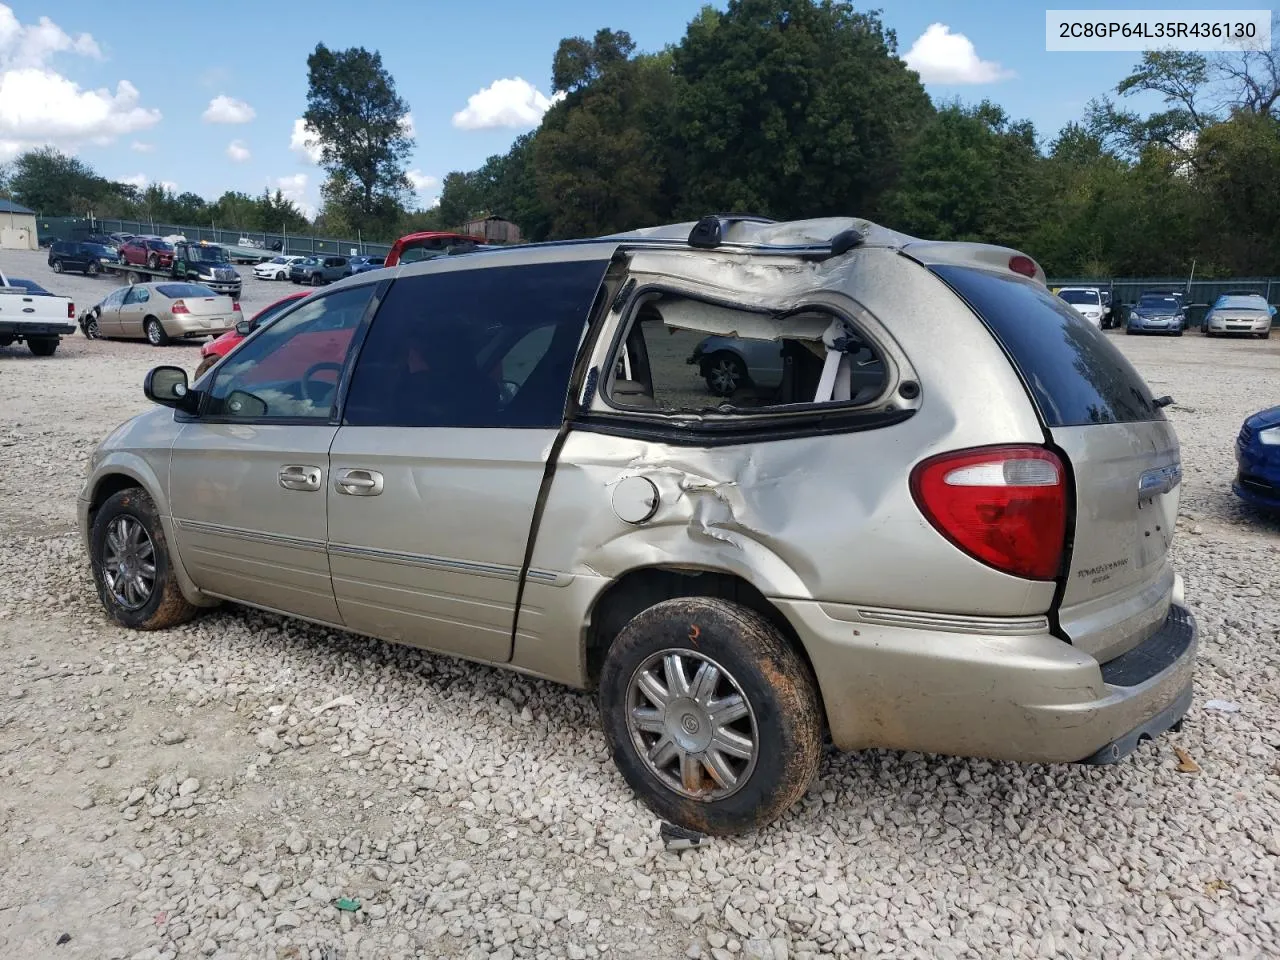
xmin=0 ymin=252 xmax=1280 ymax=960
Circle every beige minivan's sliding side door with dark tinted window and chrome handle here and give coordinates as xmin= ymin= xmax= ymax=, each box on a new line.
xmin=328 ymin=248 xmax=612 ymax=660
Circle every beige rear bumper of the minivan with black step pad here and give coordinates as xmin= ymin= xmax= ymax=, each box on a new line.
xmin=774 ymin=600 xmax=1198 ymax=763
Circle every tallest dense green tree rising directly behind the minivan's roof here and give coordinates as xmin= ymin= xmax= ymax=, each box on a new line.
xmin=673 ymin=0 xmax=933 ymax=218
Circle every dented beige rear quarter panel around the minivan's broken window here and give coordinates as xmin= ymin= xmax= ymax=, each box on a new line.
xmin=515 ymin=248 xmax=1053 ymax=678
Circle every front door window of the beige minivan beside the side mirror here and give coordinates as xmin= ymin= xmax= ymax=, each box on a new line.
xmin=204 ymin=284 xmax=372 ymax=420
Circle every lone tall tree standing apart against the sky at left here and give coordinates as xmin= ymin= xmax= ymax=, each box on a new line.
xmin=303 ymin=44 xmax=413 ymax=233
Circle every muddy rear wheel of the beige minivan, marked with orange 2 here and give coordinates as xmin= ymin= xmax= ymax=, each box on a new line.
xmin=599 ymin=596 xmax=823 ymax=836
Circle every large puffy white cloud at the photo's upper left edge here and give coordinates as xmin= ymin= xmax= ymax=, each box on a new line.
xmin=0 ymin=4 xmax=160 ymax=159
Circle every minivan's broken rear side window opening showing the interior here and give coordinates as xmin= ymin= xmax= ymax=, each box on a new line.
xmin=605 ymin=293 xmax=887 ymax=413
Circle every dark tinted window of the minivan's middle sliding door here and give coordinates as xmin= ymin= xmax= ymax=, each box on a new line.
xmin=344 ymin=261 xmax=605 ymax=428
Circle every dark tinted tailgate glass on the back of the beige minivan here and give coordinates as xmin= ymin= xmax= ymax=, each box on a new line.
xmin=932 ymin=265 xmax=1165 ymax=428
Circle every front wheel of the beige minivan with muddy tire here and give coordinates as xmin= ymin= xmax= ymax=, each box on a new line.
xmin=90 ymin=486 xmax=198 ymax=630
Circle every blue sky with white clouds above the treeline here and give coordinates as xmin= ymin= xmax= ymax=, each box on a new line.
xmin=0 ymin=0 xmax=1259 ymax=212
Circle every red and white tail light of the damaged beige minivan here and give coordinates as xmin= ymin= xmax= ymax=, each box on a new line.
xmin=911 ymin=445 xmax=1068 ymax=580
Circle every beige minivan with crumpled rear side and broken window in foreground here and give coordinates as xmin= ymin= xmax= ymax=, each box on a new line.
xmin=79 ymin=218 xmax=1197 ymax=833
